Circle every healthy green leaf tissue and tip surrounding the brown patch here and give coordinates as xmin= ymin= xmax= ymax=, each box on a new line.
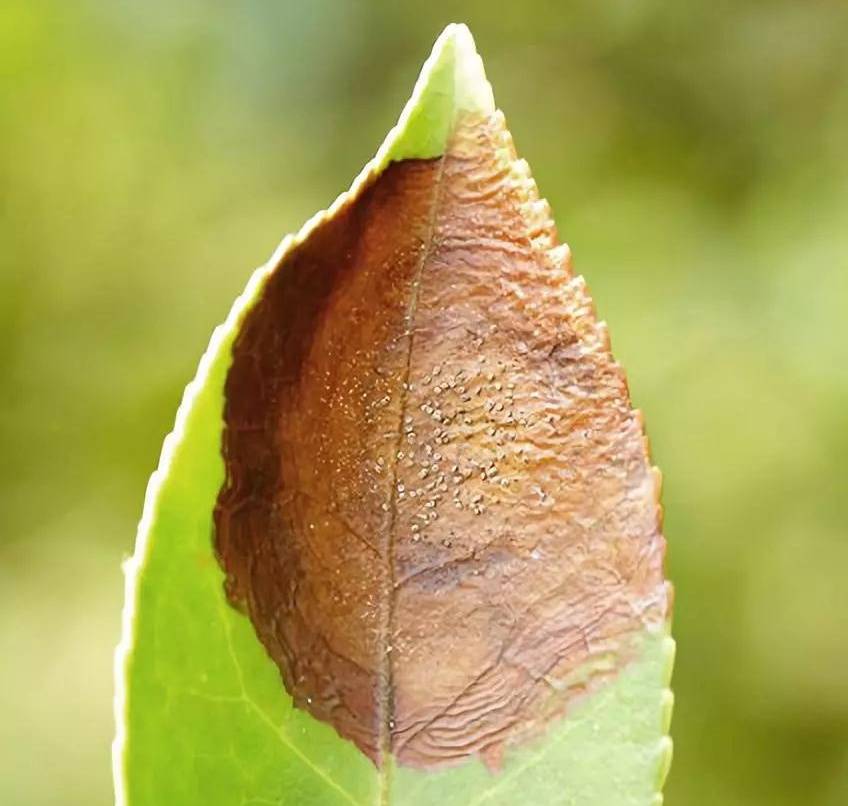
xmin=114 ymin=26 xmax=674 ymax=806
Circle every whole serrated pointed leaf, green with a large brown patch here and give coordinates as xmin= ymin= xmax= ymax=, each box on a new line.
xmin=113 ymin=25 xmax=674 ymax=806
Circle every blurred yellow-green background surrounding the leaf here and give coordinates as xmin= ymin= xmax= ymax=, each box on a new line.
xmin=0 ymin=0 xmax=848 ymax=806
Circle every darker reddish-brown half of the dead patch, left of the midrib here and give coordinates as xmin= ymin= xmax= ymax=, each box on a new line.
xmin=215 ymin=156 xmax=438 ymax=758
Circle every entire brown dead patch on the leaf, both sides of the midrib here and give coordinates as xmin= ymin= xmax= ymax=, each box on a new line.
xmin=215 ymin=114 xmax=668 ymax=768
